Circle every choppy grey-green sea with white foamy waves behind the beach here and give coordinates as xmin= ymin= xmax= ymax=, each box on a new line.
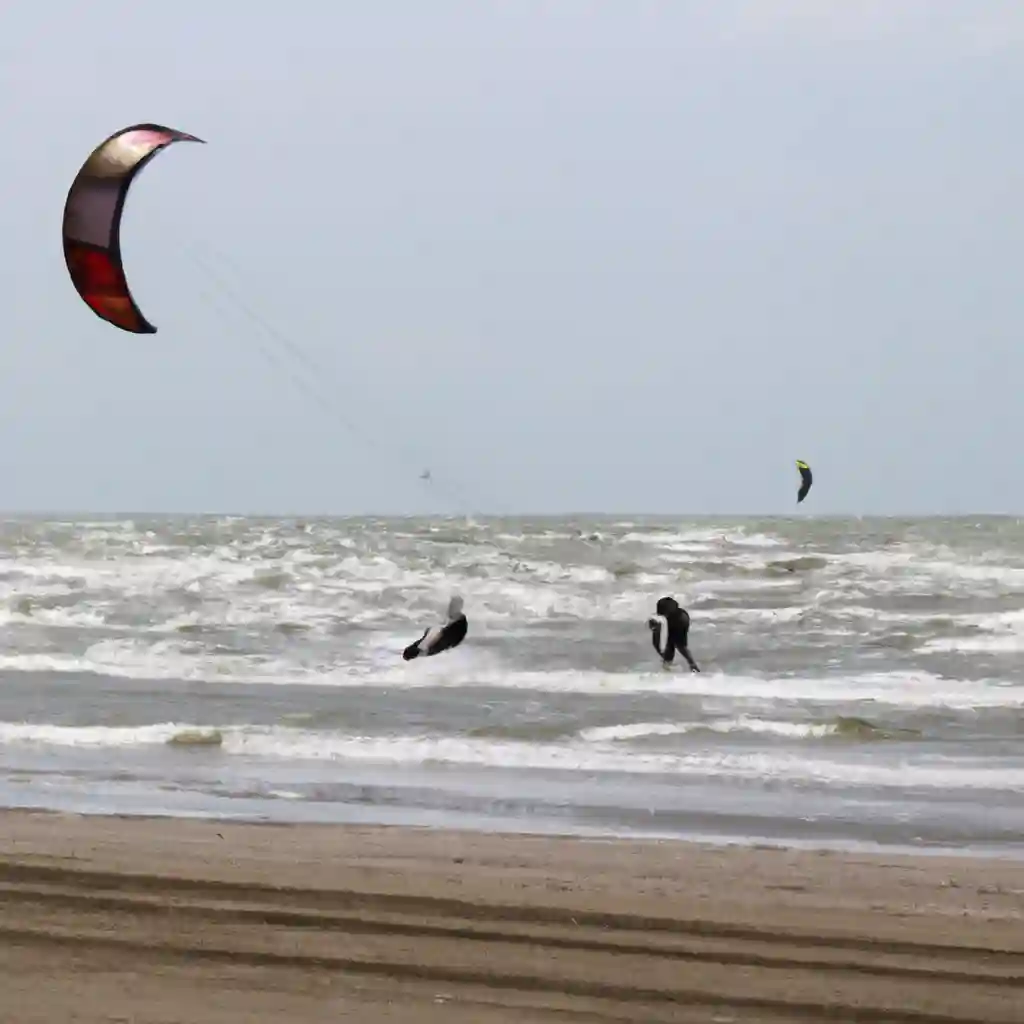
xmin=0 ymin=516 xmax=1024 ymax=856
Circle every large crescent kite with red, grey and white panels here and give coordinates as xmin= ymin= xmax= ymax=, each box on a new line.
xmin=62 ymin=124 xmax=203 ymax=334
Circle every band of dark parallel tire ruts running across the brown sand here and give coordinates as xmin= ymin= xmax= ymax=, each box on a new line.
xmin=0 ymin=862 xmax=1024 ymax=1024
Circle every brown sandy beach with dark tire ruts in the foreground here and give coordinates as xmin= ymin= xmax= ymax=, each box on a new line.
xmin=0 ymin=811 xmax=1024 ymax=1024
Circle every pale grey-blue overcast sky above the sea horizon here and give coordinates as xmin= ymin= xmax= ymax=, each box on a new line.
xmin=0 ymin=0 xmax=1024 ymax=514
